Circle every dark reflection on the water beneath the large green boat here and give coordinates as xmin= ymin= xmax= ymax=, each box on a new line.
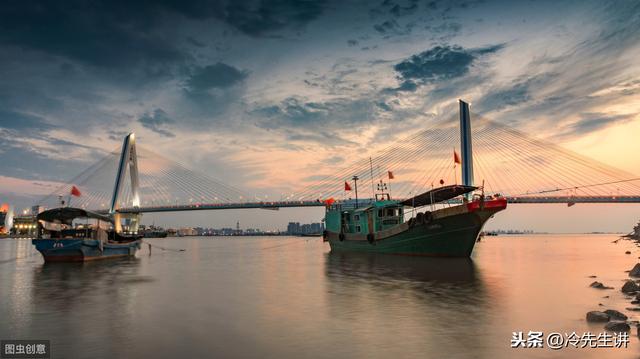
xmin=325 ymin=252 xmax=492 ymax=358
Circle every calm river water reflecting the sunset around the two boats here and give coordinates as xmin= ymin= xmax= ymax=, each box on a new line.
xmin=0 ymin=235 xmax=640 ymax=359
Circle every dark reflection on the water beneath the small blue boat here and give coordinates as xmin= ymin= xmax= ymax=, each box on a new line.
xmin=25 ymin=257 xmax=152 ymax=357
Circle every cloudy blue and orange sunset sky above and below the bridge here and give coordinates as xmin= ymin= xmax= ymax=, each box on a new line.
xmin=0 ymin=0 xmax=640 ymax=231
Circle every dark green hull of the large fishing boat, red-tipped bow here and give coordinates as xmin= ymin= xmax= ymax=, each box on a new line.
xmin=327 ymin=202 xmax=504 ymax=257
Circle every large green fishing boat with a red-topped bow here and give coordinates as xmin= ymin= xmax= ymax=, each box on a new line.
xmin=323 ymin=185 xmax=507 ymax=257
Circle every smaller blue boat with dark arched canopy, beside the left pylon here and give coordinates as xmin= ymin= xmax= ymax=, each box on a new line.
xmin=32 ymin=207 xmax=142 ymax=262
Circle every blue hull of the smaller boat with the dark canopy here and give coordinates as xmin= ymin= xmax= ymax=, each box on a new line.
xmin=31 ymin=238 xmax=142 ymax=262
